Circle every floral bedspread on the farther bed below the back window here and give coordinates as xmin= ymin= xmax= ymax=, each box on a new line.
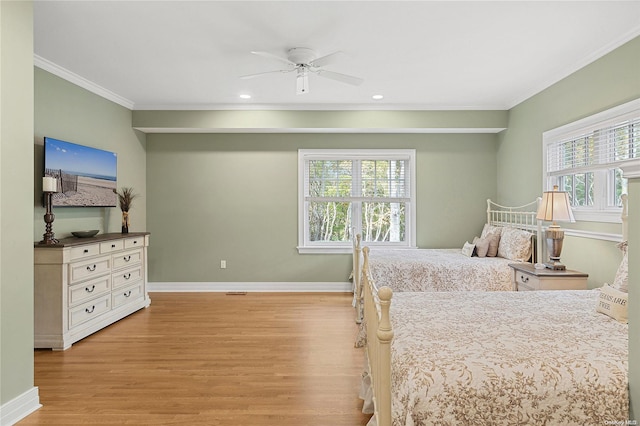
xmin=369 ymin=249 xmax=514 ymax=292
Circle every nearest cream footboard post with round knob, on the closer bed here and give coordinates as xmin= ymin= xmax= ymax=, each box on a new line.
xmin=376 ymin=287 xmax=393 ymax=426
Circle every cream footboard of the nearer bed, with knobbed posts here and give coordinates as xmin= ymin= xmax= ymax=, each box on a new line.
xmin=362 ymin=247 xmax=393 ymax=426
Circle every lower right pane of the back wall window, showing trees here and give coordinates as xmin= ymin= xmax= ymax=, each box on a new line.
xmin=362 ymin=202 xmax=406 ymax=243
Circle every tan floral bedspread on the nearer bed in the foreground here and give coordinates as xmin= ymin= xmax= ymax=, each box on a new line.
xmin=391 ymin=290 xmax=629 ymax=426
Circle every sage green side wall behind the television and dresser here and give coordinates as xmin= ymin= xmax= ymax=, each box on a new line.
xmin=32 ymin=68 xmax=147 ymax=241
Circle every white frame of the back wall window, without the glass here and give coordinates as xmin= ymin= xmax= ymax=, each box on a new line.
xmin=297 ymin=149 xmax=416 ymax=253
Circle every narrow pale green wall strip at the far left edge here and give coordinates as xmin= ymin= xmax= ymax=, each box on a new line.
xmin=0 ymin=1 xmax=33 ymax=406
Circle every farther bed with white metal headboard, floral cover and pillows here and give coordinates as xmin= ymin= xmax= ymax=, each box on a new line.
xmin=352 ymin=199 xmax=542 ymax=323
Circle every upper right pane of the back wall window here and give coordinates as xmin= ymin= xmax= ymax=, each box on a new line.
xmin=362 ymin=160 xmax=406 ymax=197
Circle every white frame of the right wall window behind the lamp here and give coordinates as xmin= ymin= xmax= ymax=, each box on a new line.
xmin=542 ymin=99 xmax=640 ymax=223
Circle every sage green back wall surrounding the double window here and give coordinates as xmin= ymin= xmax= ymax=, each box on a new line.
xmin=147 ymin=133 xmax=496 ymax=282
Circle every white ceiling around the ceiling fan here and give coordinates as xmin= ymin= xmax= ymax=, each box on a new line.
xmin=34 ymin=0 xmax=640 ymax=110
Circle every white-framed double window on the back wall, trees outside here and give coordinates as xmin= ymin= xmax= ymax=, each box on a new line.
xmin=298 ymin=149 xmax=415 ymax=253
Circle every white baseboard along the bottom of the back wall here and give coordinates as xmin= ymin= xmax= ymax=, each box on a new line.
xmin=148 ymin=282 xmax=352 ymax=293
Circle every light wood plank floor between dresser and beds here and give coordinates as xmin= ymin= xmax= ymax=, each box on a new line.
xmin=18 ymin=293 xmax=370 ymax=426
